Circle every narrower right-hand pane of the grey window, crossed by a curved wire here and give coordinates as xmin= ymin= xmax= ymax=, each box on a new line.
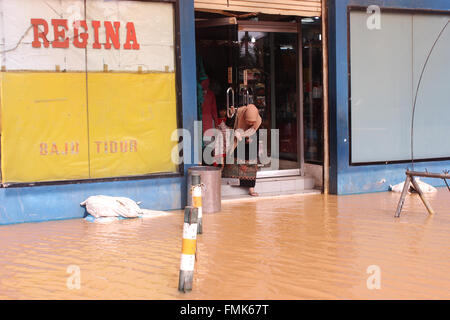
xmin=413 ymin=14 xmax=450 ymax=159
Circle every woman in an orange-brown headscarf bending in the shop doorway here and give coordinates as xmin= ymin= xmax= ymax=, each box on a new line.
xmin=222 ymin=104 xmax=262 ymax=197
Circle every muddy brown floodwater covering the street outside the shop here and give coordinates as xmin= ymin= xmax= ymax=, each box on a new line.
xmin=0 ymin=189 xmax=450 ymax=300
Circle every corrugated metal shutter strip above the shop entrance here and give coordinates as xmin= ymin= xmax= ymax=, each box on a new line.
xmin=194 ymin=0 xmax=321 ymax=17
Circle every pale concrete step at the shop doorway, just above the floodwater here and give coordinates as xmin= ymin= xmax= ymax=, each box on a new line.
xmin=222 ymin=176 xmax=320 ymax=199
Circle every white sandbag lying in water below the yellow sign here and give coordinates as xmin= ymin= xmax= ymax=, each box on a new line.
xmin=80 ymin=195 xmax=141 ymax=218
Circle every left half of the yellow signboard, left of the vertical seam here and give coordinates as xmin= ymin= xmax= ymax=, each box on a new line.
xmin=1 ymin=72 xmax=89 ymax=182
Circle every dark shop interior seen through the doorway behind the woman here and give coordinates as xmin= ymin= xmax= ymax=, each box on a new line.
xmin=195 ymin=10 xmax=323 ymax=176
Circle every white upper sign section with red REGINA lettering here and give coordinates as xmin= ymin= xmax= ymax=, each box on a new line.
xmin=0 ymin=0 xmax=175 ymax=72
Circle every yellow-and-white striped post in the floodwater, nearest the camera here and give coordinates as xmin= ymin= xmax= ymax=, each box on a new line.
xmin=178 ymin=207 xmax=198 ymax=292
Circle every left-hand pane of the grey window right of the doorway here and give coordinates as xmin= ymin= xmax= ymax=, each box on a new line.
xmin=350 ymin=12 xmax=412 ymax=162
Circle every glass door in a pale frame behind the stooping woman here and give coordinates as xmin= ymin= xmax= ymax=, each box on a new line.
xmin=238 ymin=31 xmax=301 ymax=176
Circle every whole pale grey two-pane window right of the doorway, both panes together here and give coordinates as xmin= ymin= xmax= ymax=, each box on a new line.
xmin=350 ymin=11 xmax=450 ymax=163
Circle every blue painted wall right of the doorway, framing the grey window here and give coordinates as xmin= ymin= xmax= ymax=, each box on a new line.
xmin=328 ymin=0 xmax=450 ymax=194
